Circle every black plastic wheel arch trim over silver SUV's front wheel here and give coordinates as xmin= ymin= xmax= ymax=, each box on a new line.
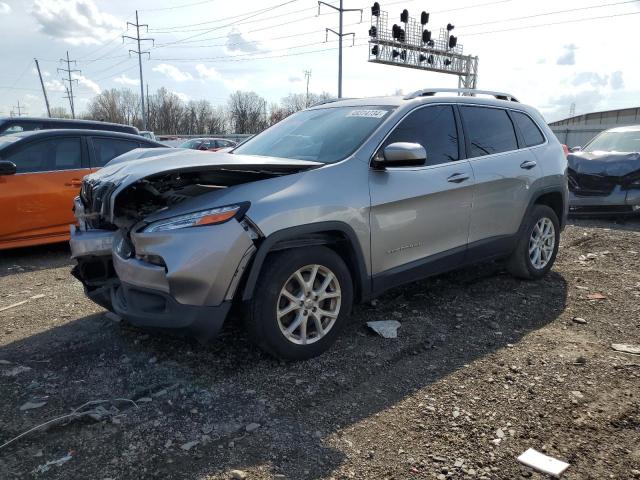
xmin=242 ymin=221 xmax=371 ymax=301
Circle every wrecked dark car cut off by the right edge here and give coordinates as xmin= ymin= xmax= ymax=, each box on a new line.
xmin=567 ymin=125 xmax=640 ymax=215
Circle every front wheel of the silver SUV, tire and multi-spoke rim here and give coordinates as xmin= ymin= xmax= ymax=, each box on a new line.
xmin=245 ymin=247 xmax=353 ymax=360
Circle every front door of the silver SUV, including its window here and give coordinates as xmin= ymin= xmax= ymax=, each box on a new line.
xmin=369 ymin=105 xmax=474 ymax=289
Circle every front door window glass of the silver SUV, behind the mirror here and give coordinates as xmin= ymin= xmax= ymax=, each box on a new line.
xmin=383 ymin=105 xmax=460 ymax=165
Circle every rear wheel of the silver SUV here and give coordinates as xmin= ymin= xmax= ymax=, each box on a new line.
xmin=507 ymin=205 xmax=560 ymax=279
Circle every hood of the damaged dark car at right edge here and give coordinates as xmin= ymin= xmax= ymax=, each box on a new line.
xmin=567 ymin=152 xmax=640 ymax=179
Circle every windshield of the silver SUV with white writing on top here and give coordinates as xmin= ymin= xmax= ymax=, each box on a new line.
xmin=233 ymin=106 xmax=394 ymax=163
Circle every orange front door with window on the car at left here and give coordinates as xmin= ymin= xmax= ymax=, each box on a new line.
xmin=0 ymin=135 xmax=89 ymax=246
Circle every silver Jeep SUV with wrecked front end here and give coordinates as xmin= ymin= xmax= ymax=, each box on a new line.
xmin=71 ymin=89 xmax=568 ymax=359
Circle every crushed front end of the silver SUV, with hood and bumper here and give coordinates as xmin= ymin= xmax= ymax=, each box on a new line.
xmin=70 ymin=151 xmax=318 ymax=338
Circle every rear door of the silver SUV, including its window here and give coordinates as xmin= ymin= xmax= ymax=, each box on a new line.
xmin=459 ymin=106 xmax=541 ymax=246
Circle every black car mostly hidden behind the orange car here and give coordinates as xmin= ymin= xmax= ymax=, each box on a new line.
xmin=0 ymin=117 xmax=138 ymax=135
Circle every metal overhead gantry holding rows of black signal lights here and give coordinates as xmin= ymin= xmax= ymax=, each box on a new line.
xmin=369 ymin=2 xmax=478 ymax=89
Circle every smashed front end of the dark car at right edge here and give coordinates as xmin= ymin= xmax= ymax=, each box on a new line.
xmin=567 ymin=152 xmax=640 ymax=215
